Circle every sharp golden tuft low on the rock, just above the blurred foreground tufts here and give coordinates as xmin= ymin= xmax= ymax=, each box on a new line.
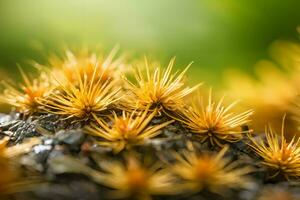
xmin=85 ymin=107 xmax=173 ymax=153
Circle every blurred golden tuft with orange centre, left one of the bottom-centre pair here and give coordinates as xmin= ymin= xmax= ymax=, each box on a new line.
xmin=97 ymin=155 xmax=176 ymax=200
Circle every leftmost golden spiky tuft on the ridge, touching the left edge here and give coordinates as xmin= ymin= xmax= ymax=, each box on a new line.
xmin=0 ymin=68 xmax=54 ymax=115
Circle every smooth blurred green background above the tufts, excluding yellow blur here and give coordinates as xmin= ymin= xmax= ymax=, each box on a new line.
xmin=0 ymin=0 xmax=300 ymax=85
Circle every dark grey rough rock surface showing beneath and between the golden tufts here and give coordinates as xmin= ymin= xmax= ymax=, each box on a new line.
xmin=0 ymin=114 xmax=300 ymax=200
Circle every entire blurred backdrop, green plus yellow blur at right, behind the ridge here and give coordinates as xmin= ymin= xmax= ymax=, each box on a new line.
xmin=0 ymin=0 xmax=300 ymax=136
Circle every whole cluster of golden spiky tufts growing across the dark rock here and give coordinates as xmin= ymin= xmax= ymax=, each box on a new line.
xmin=0 ymin=47 xmax=300 ymax=199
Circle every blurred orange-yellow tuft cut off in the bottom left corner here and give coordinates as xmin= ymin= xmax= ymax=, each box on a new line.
xmin=0 ymin=137 xmax=40 ymax=195
